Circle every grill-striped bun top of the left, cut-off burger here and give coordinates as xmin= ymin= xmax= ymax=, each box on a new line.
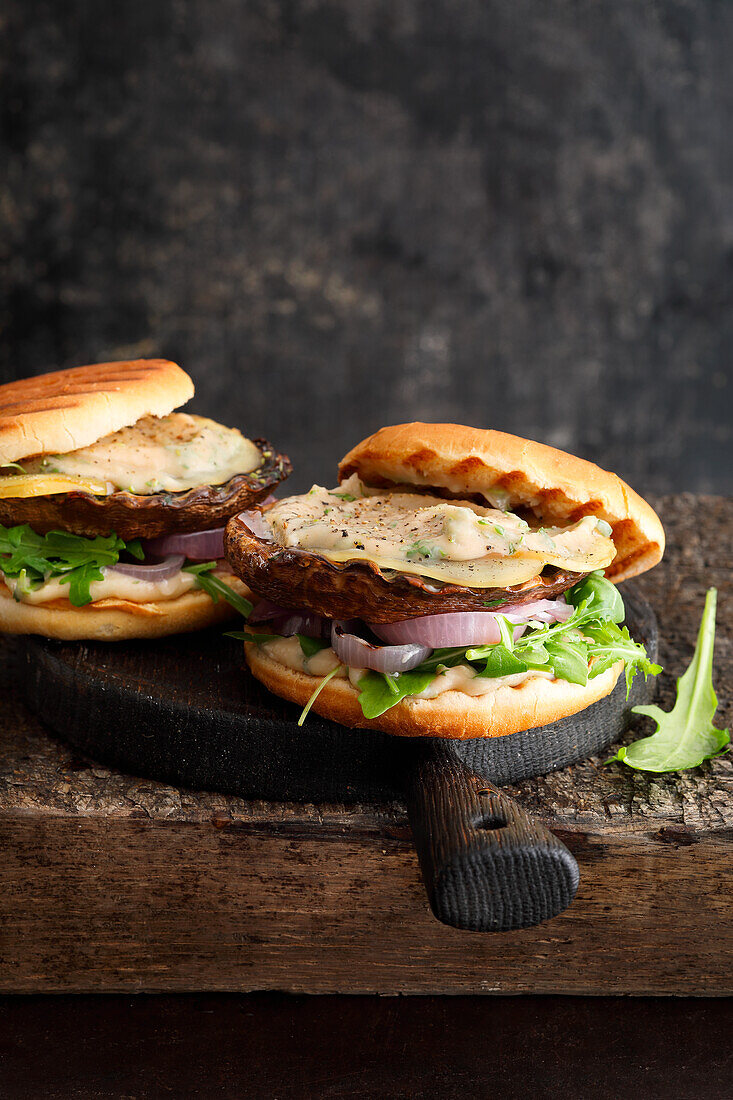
xmin=0 ymin=359 xmax=194 ymax=465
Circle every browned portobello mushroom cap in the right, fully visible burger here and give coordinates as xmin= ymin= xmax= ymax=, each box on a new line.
xmin=225 ymin=508 xmax=588 ymax=623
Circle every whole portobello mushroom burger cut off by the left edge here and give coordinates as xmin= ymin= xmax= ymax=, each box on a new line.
xmin=0 ymin=359 xmax=291 ymax=641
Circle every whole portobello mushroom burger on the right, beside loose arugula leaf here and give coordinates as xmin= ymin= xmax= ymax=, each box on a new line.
xmin=226 ymin=424 xmax=665 ymax=738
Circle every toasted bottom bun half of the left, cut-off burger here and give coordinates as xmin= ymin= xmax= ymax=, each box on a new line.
xmin=0 ymin=575 xmax=251 ymax=641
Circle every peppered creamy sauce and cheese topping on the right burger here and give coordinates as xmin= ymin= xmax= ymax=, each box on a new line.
xmin=266 ymin=475 xmax=616 ymax=589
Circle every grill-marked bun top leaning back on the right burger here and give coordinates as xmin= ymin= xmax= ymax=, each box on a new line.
xmin=339 ymin=424 xmax=665 ymax=581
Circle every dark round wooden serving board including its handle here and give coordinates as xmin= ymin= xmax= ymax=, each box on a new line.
xmin=17 ymin=586 xmax=658 ymax=933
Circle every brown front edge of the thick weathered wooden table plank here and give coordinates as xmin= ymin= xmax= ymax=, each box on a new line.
xmin=0 ymin=816 xmax=733 ymax=994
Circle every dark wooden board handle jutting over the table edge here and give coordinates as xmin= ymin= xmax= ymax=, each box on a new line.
xmin=406 ymin=748 xmax=580 ymax=932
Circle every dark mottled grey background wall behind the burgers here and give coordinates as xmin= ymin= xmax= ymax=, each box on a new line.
xmin=0 ymin=0 xmax=733 ymax=492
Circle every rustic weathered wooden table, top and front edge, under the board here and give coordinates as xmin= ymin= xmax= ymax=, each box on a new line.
xmin=0 ymin=496 xmax=733 ymax=994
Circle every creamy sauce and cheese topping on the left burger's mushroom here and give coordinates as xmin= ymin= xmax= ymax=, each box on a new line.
xmin=8 ymin=413 xmax=262 ymax=496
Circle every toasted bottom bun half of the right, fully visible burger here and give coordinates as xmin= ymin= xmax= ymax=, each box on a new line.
xmin=244 ymin=642 xmax=623 ymax=740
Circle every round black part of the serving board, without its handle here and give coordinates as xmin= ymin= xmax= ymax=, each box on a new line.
xmin=19 ymin=586 xmax=657 ymax=802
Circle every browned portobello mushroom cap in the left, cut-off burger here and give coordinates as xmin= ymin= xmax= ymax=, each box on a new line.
xmin=0 ymin=439 xmax=293 ymax=539
